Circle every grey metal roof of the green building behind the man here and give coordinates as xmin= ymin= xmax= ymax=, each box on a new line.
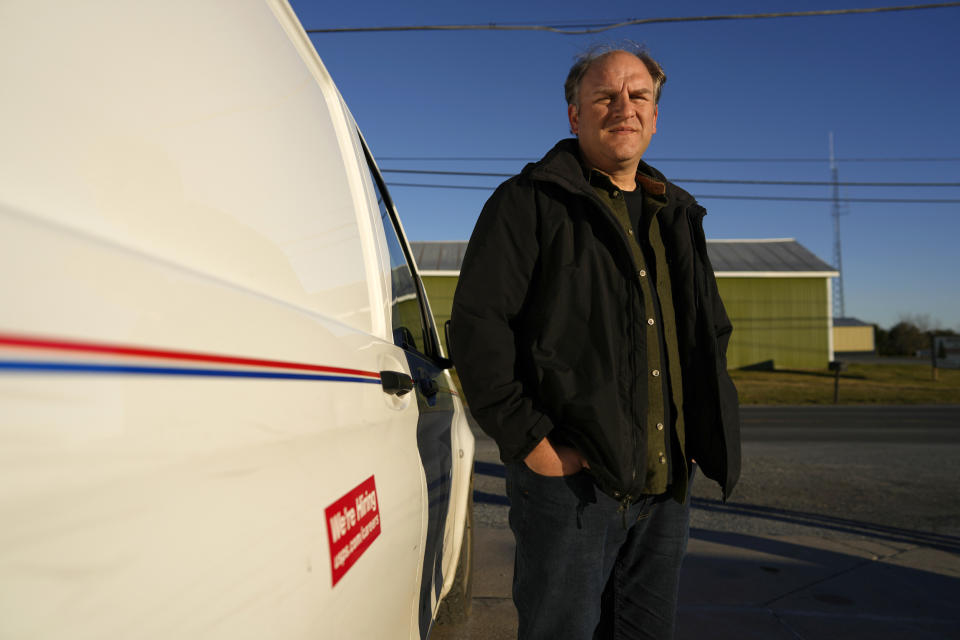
xmin=410 ymin=238 xmax=837 ymax=277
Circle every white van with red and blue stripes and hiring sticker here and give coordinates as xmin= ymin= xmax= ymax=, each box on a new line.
xmin=0 ymin=0 xmax=474 ymax=640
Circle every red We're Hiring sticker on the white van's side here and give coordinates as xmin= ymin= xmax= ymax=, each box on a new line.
xmin=325 ymin=476 xmax=380 ymax=586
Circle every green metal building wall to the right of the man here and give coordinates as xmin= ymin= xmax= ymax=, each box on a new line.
xmin=717 ymin=278 xmax=830 ymax=369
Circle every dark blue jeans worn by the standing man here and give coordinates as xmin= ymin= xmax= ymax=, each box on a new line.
xmin=507 ymin=463 xmax=693 ymax=640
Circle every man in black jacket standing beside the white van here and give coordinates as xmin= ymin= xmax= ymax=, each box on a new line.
xmin=452 ymin=50 xmax=740 ymax=639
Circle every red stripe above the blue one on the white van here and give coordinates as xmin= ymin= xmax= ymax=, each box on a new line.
xmin=0 ymin=333 xmax=380 ymax=380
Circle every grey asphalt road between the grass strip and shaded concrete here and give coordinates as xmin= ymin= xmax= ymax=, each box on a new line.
xmin=474 ymin=405 xmax=960 ymax=535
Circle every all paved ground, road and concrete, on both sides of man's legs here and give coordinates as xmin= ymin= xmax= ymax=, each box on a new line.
xmin=430 ymin=406 xmax=960 ymax=640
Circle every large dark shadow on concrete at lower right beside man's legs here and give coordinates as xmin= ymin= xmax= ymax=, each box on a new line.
xmin=678 ymin=529 xmax=960 ymax=640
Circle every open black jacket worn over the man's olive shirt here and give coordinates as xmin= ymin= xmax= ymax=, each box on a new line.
xmin=451 ymin=140 xmax=740 ymax=499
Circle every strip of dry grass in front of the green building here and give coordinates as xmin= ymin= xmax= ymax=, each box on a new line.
xmin=730 ymin=363 xmax=960 ymax=404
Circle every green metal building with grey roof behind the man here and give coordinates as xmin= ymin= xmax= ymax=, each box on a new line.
xmin=411 ymin=238 xmax=837 ymax=369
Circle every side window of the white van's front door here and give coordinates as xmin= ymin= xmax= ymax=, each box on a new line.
xmin=370 ymin=170 xmax=429 ymax=353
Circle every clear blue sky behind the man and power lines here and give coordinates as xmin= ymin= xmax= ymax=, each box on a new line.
xmin=292 ymin=0 xmax=960 ymax=330
